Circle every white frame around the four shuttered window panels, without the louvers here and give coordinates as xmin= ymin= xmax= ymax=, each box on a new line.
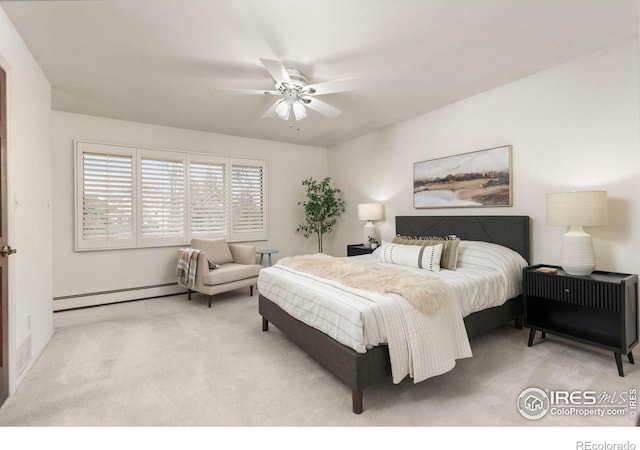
xmin=74 ymin=140 xmax=268 ymax=252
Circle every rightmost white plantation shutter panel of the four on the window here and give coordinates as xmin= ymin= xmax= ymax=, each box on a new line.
xmin=230 ymin=158 xmax=267 ymax=241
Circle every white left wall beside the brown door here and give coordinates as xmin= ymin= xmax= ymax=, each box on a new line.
xmin=0 ymin=8 xmax=53 ymax=393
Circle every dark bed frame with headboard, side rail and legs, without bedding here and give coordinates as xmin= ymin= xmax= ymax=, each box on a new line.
xmin=258 ymin=216 xmax=529 ymax=414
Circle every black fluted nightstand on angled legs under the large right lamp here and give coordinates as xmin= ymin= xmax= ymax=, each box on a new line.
xmin=523 ymin=265 xmax=638 ymax=377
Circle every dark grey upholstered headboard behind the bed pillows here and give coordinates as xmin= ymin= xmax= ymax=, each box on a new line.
xmin=396 ymin=216 xmax=530 ymax=262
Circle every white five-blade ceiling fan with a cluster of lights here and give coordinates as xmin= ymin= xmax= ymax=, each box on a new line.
xmin=216 ymin=58 xmax=358 ymax=124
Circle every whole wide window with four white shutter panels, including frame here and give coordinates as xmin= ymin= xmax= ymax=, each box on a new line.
xmin=76 ymin=141 xmax=267 ymax=250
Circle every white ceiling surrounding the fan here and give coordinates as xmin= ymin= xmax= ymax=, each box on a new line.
xmin=0 ymin=0 xmax=637 ymax=147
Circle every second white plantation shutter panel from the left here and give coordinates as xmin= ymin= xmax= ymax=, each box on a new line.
xmin=139 ymin=150 xmax=187 ymax=246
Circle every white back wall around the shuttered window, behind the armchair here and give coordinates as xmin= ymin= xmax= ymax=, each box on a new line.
xmin=52 ymin=111 xmax=327 ymax=308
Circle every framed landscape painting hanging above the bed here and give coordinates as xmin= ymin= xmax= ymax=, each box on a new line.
xmin=413 ymin=145 xmax=512 ymax=208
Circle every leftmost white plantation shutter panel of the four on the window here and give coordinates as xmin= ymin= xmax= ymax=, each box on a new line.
xmin=76 ymin=143 xmax=135 ymax=250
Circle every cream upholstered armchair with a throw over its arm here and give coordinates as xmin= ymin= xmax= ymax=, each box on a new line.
xmin=178 ymin=239 xmax=262 ymax=308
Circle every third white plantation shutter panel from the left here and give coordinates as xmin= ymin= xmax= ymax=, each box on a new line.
xmin=189 ymin=155 xmax=228 ymax=238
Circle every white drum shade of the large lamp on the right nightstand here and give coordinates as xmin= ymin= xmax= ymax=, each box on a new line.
xmin=547 ymin=191 xmax=607 ymax=227
